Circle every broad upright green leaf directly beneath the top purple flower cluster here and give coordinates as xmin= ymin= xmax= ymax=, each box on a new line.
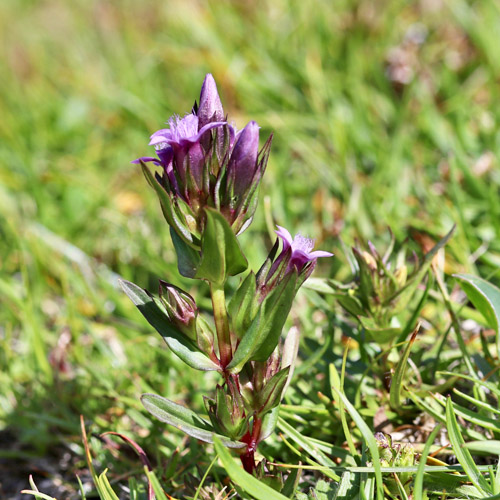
xmin=196 ymin=208 xmax=248 ymax=285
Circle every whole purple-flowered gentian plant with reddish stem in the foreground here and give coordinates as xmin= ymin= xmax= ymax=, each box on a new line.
xmin=123 ymin=75 xmax=332 ymax=472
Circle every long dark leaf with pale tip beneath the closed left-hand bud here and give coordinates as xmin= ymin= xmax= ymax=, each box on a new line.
xmin=121 ymin=280 xmax=220 ymax=370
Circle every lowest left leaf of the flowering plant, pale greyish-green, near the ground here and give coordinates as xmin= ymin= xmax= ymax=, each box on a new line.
xmin=141 ymin=394 xmax=245 ymax=448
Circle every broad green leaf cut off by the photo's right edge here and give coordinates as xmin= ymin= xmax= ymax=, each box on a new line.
xmin=453 ymin=274 xmax=500 ymax=353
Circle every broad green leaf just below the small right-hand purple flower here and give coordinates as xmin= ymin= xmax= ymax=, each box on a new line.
xmin=227 ymin=272 xmax=297 ymax=373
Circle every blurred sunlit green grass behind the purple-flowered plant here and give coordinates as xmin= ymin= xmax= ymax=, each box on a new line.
xmin=0 ymin=0 xmax=500 ymax=498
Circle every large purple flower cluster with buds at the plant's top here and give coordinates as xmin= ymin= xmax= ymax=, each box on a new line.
xmin=133 ymin=74 xmax=271 ymax=242
